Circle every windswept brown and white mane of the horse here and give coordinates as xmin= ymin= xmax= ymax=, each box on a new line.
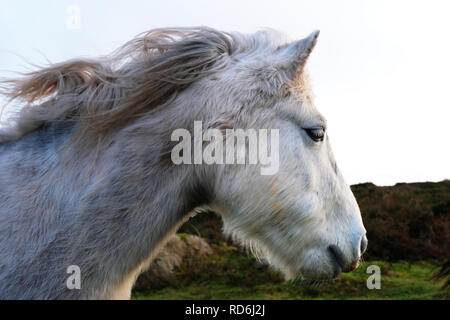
xmin=0 ymin=27 xmax=234 ymax=143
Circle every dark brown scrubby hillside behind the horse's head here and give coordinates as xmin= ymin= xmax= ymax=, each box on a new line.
xmin=180 ymin=180 xmax=450 ymax=261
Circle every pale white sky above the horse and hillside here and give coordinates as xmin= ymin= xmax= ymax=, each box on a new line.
xmin=0 ymin=0 xmax=450 ymax=185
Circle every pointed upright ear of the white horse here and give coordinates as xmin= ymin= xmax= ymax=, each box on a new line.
xmin=276 ymin=30 xmax=320 ymax=79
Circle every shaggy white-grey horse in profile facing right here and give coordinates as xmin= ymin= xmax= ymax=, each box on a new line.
xmin=0 ymin=27 xmax=367 ymax=299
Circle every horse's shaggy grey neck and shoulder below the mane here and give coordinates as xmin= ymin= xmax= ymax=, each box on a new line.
xmin=0 ymin=110 xmax=214 ymax=298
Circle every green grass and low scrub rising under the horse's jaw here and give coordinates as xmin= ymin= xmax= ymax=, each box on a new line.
xmin=133 ymin=249 xmax=444 ymax=300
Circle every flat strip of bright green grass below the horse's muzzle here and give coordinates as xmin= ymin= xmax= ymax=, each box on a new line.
xmin=133 ymin=261 xmax=450 ymax=300
